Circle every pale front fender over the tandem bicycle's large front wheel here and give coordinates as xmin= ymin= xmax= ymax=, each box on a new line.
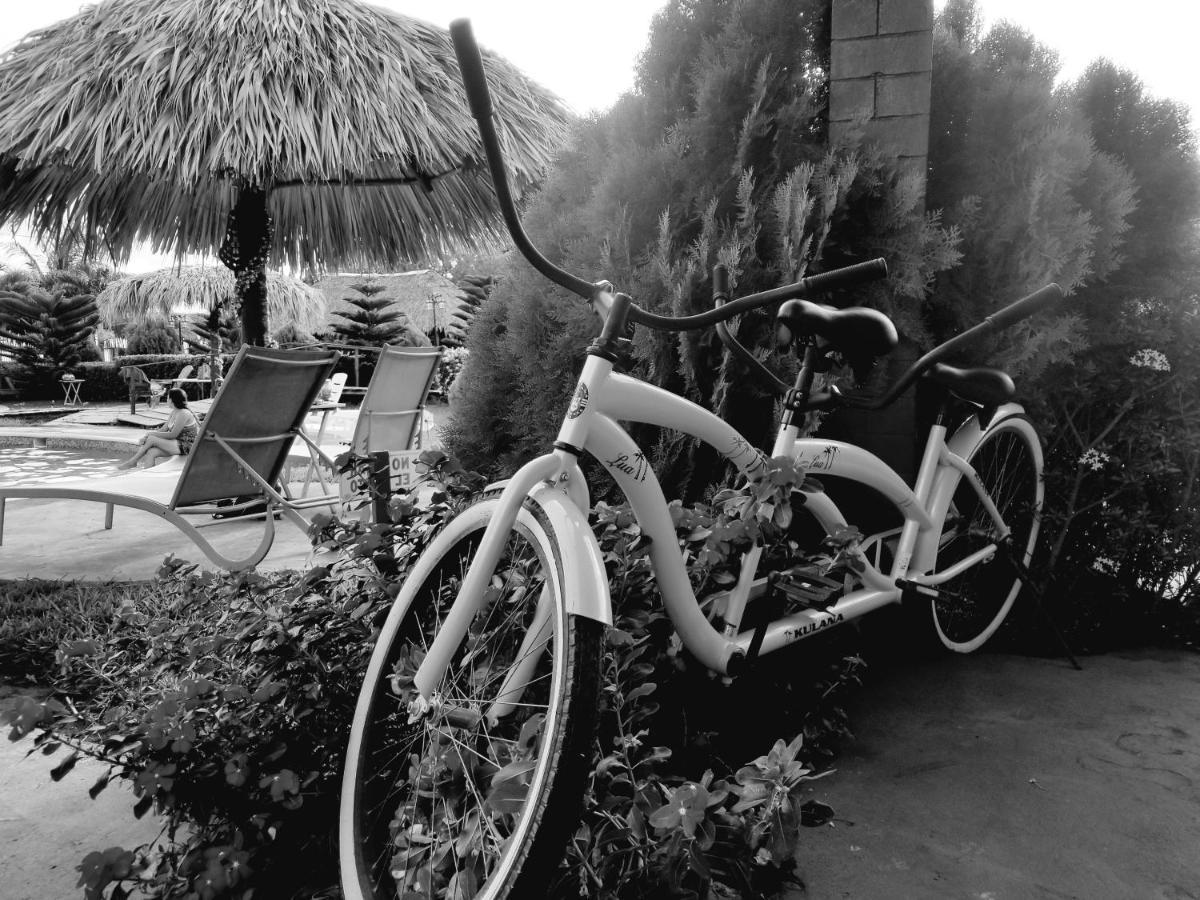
xmin=529 ymin=484 xmax=612 ymax=626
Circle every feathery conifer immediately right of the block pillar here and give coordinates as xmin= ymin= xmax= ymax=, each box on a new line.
xmin=928 ymin=0 xmax=1135 ymax=372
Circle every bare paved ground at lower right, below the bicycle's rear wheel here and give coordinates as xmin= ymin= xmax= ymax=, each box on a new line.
xmin=796 ymin=652 xmax=1200 ymax=900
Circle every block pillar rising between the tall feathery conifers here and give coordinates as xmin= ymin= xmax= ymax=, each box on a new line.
xmin=829 ymin=0 xmax=934 ymax=184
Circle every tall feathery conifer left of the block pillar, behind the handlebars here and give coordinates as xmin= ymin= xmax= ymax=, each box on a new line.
xmin=450 ymin=0 xmax=954 ymax=492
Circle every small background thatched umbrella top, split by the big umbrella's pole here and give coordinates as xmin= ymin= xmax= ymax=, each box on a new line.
xmin=96 ymin=266 xmax=326 ymax=331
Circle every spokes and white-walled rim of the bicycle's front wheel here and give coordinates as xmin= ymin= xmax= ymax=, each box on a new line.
xmin=343 ymin=508 xmax=600 ymax=900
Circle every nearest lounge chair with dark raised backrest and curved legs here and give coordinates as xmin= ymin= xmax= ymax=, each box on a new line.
xmin=0 ymin=347 xmax=338 ymax=571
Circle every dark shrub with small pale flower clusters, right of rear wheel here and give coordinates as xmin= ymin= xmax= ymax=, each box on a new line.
xmin=1017 ymin=295 xmax=1200 ymax=650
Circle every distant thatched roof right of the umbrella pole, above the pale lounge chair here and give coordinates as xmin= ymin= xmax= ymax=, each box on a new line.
xmin=314 ymin=269 xmax=470 ymax=340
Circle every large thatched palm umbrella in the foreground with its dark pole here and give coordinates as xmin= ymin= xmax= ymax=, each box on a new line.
xmin=0 ymin=0 xmax=566 ymax=343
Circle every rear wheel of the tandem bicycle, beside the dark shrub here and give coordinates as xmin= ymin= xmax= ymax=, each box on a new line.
xmin=932 ymin=415 xmax=1043 ymax=653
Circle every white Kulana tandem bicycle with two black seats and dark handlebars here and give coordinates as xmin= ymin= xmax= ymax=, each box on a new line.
xmin=340 ymin=22 xmax=1061 ymax=900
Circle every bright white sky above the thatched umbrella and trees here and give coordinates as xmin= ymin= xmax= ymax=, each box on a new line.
xmin=0 ymin=0 xmax=1200 ymax=272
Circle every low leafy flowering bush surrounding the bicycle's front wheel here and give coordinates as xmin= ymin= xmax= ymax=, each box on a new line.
xmin=2 ymin=452 xmax=862 ymax=900
